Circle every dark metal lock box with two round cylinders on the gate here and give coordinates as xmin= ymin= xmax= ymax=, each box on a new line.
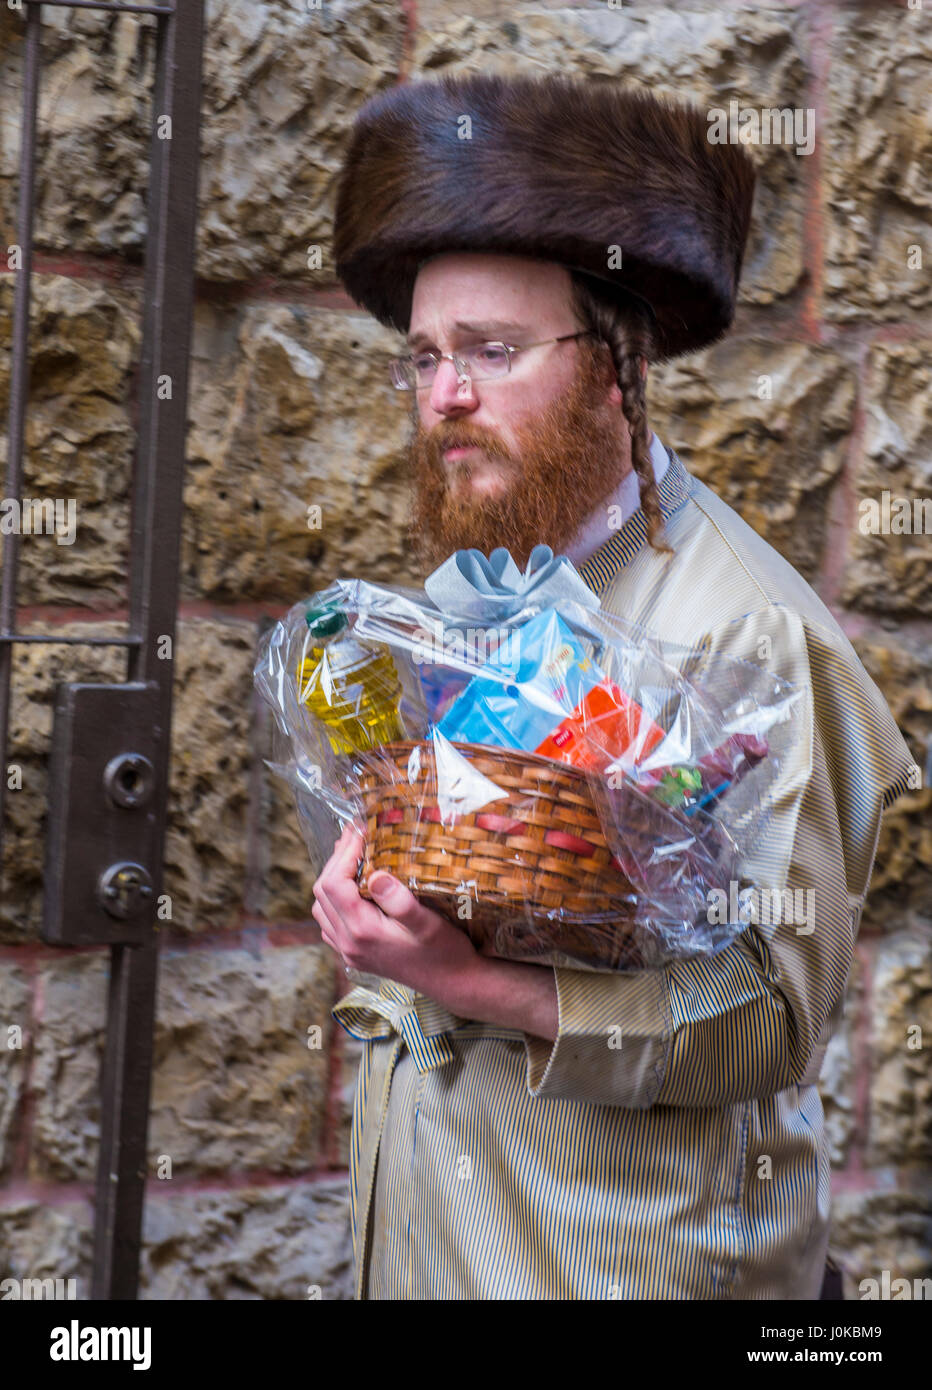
xmin=40 ymin=681 xmax=161 ymax=947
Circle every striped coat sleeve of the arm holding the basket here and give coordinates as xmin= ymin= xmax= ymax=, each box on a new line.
xmin=525 ymin=605 xmax=914 ymax=1109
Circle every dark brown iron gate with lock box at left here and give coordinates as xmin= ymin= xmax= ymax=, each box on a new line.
xmin=0 ymin=0 xmax=204 ymax=1298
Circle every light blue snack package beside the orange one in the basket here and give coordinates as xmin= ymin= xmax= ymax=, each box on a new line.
xmin=436 ymin=609 xmax=603 ymax=752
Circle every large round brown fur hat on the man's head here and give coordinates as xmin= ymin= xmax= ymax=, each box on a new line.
xmin=333 ymin=74 xmax=756 ymax=361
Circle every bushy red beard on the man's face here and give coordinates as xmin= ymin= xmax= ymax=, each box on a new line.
xmin=407 ymin=343 xmax=631 ymax=574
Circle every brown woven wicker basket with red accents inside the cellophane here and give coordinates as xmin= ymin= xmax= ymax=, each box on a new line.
xmin=358 ymin=741 xmax=639 ymax=970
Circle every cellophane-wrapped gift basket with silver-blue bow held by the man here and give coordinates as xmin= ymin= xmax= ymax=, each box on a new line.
xmin=254 ymin=545 xmax=801 ymax=970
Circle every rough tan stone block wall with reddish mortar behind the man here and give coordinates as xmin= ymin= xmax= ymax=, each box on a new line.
xmin=0 ymin=0 xmax=932 ymax=1298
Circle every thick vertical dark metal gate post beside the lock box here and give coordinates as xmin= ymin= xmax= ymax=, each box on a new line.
xmin=92 ymin=0 xmax=204 ymax=1298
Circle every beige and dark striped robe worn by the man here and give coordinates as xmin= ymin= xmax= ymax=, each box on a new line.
xmin=333 ymin=450 xmax=913 ymax=1300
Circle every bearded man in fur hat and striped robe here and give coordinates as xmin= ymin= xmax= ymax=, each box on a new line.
xmin=314 ymin=78 xmax=913 ymax=1298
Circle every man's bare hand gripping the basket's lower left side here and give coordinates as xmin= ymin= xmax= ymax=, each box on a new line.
xmin=311 ymin=824 xmax=482 ymax=1004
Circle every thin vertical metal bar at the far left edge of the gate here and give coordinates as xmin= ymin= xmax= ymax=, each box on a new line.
xmin=0 ymin=10 xmax=42 ymax=837
